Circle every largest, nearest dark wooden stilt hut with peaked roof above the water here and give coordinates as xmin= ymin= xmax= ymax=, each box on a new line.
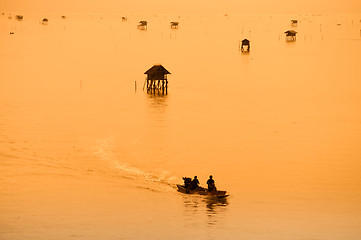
xmin=144 ymin=65 xmax=170 ymax=94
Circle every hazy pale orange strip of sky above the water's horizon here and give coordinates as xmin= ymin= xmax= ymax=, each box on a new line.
xmin=0 ymin=0 xmax=361 ymax=14
